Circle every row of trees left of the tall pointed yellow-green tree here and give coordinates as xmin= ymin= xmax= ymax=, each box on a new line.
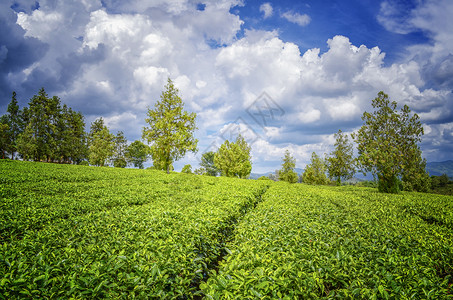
xmin=0 ymin=88 xmax=149 ymax=168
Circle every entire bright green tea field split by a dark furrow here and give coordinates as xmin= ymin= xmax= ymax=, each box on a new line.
xmin=0 ymin=160 xmax=453 ymax=299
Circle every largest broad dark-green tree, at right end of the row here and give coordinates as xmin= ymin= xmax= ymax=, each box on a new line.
xmin=354 ymin=91 xmax=426 ymax=193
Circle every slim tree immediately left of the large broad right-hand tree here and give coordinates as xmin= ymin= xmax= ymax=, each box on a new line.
xmin=326 ymin=130 xmax=355 ymax=185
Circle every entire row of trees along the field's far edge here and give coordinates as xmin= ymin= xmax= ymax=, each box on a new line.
xmin=0 ymin=78 xmax=430 ymax=193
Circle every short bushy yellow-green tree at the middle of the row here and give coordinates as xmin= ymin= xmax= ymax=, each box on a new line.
xmin=214 ymin=135 xmax=252 ymax=178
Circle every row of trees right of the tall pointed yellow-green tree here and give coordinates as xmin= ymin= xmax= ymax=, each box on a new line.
xmin=183 ymin=91 xmax=431 ymax=193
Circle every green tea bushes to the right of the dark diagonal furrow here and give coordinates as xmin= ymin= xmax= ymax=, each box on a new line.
xmin=200 ymin=182 xmax=453 ymax=299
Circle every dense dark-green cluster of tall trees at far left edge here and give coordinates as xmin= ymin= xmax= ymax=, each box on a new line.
xmin=1 ymin=88 xmax=87 ymax=163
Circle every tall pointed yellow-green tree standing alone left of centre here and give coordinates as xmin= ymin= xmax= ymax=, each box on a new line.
xmin=142 ymin=78 xmax=198 ymax=174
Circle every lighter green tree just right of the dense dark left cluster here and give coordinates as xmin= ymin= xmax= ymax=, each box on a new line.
xmin=88 ymin=121 xmax=115 ymax=167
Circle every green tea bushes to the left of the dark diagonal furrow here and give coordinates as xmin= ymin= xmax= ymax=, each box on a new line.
xmin=0 ymin=160 xmax=266 ymax=299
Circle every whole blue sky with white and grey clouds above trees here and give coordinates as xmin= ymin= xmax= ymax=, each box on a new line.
xmin=0 ymin=0 xmax=453 ymax=173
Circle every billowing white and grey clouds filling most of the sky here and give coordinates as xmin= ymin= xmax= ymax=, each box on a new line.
xmin=0 ymin=0 xmax=453 ymax=171
